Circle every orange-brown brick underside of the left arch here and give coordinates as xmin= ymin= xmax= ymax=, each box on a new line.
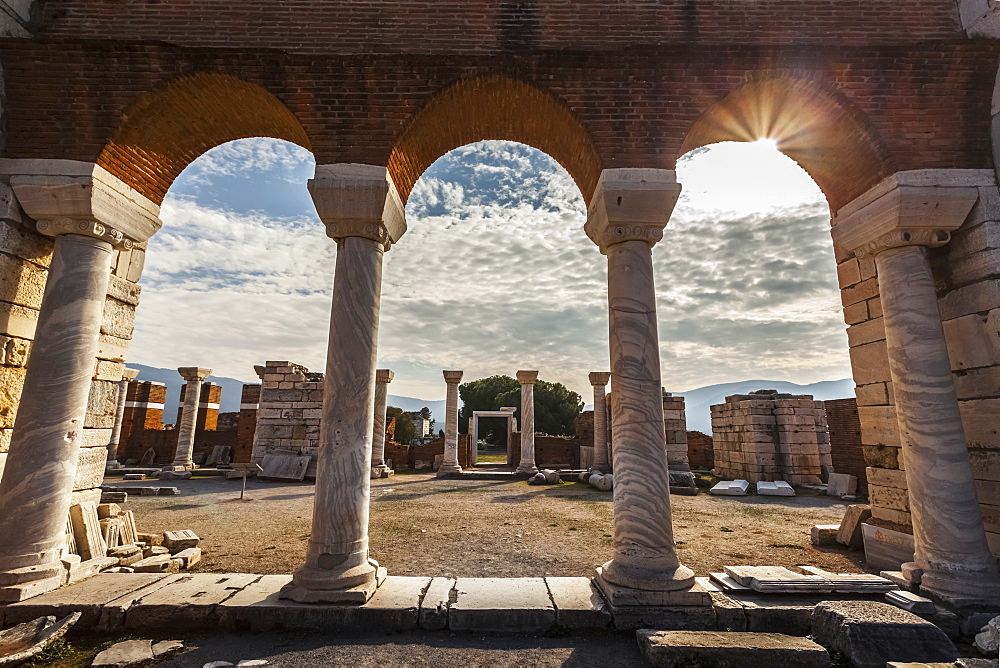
xmin=97 ymin=72 xmax=312 ymax=204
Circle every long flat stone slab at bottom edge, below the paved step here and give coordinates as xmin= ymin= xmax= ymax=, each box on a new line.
xmin=636 ymin=629 xmax=830 ymax=668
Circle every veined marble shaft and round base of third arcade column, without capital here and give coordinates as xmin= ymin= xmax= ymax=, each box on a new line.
xmin=601 ymin=241 xmax=694 ymax=590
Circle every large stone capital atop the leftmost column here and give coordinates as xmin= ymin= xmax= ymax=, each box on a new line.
xmin=0 ymin=159 xmax=162 ymax=250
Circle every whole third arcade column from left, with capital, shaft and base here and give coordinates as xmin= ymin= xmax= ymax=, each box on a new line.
xmin=584 ymin=169 xmax=708 ymax=606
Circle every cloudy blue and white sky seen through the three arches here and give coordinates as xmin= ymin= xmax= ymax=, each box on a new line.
xmin=130 ymin=134 xmax=850 ymax=400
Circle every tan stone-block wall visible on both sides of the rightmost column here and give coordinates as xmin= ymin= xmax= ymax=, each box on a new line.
xmin=835 ymin=170 xmax=1000 ymax=555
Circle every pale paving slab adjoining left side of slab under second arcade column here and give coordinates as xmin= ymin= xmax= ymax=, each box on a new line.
xmin=125 ymin=573 xmax=262 ymax=631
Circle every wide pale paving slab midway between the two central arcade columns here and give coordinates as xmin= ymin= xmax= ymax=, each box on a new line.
xmin=448 ymin=578 xmax=556 ymax=633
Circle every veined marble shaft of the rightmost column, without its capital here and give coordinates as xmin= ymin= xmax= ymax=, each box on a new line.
xmin=875 ymin=246 xmax=997 ymax=598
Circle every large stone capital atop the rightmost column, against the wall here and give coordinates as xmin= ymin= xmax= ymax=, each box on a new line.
xmin=830 ymin=169 xmax=995 ymax=257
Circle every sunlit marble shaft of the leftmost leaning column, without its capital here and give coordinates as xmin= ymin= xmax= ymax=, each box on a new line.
xmin=0 ymin=234 xmax=112 ymax=580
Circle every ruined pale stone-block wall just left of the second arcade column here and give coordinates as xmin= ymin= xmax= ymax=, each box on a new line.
xmin=252 ymin=361 xmax=323 ymax=476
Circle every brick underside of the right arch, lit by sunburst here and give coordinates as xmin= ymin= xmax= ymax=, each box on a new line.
xmin=679 ymin=76 xmax=896 ymax=211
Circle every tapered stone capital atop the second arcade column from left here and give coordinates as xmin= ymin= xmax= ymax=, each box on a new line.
xmin=308 ymin=163 xmax=406 ymax=250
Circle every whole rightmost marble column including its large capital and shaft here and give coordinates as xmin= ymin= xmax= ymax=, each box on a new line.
xmin=833 ymin=170 xmax=1000 ymax=605
